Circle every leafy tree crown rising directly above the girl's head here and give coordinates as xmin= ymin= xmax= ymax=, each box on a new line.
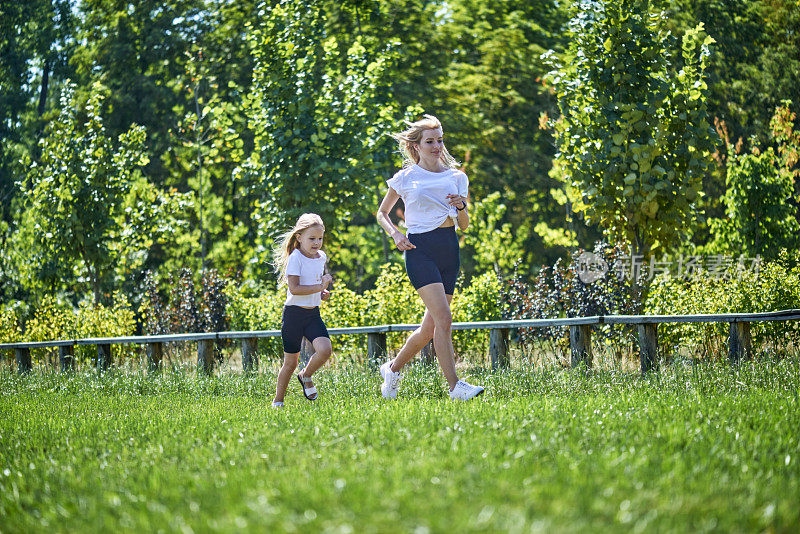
xmin=242 ymin=1 xmax=406 ymax=280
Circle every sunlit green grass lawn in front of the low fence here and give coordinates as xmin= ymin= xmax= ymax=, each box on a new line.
xmin=0 ymin=360 xmax=800 ymax=533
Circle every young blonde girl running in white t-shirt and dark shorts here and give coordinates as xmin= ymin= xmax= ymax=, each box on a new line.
xmin=272 ymin=213 xmax=332 ymax=407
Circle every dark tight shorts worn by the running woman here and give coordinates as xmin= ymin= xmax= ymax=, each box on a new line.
xmin=404 ymin=226 xmax=461 ymax=295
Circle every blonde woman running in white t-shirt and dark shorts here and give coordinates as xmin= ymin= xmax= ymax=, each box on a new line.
xmin=376 ymin=115 xmax=483 ymax=400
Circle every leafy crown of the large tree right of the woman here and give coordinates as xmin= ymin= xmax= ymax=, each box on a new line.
xmin=552 ymin=0 xmax=715 ymax=264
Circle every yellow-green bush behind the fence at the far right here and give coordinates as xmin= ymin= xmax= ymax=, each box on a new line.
xmin=645 ymin=250 xmax=800 ymax=357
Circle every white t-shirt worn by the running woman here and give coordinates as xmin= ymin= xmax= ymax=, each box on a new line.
xmin=386 ymin=165 xmax=469 ymax=234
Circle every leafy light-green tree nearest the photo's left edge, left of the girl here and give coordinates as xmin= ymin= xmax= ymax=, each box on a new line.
xmin=15 ymin=85 xmax=180 ymax=302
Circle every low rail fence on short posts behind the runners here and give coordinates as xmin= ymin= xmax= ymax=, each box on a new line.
xmin=0 ymin=309 xmax=800 ymax=373
